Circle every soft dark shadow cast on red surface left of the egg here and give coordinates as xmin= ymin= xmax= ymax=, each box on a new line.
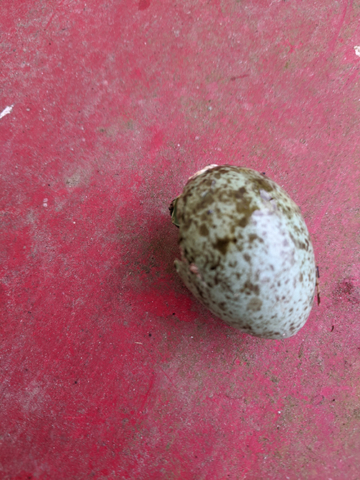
xmin=107 ymin=204 xmax=264 ymax=348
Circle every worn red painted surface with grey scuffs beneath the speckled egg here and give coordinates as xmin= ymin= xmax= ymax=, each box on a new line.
xmin=0 ymin=0 xmax=360 ymax=480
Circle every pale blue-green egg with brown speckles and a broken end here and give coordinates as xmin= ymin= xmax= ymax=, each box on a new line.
xmin=170 ymin=165 xmax=316 ymax=339
